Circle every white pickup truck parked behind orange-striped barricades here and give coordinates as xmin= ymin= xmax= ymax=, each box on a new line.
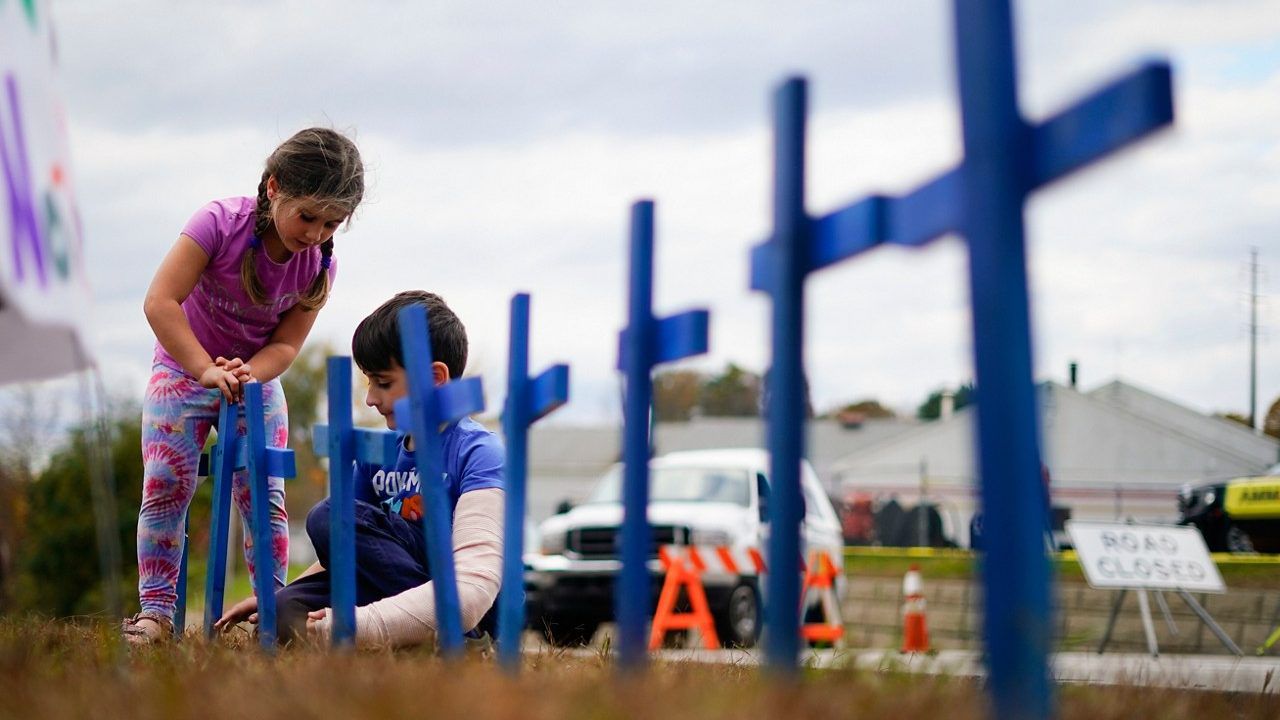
xmin=525 ymin=448 xmax=845 ymax=647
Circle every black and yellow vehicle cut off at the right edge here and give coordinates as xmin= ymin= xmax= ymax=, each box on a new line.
xmin=1178 ymin=465 xmax=1280 ymax=552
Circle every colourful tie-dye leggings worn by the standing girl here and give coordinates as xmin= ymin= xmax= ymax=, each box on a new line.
xmin=138 ymin=363 xmax=289 ymax=618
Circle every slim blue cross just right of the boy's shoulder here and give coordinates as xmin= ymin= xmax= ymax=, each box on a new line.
xmin=498 ymin=292 xmax=568 ymax=673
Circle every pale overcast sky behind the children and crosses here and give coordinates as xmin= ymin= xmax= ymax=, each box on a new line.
xmin=45 ymin=0 xmax=1280 ymax=421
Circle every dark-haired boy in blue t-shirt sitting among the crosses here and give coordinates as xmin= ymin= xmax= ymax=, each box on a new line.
xmin=216 ymin=291 xmax=504 ymax=646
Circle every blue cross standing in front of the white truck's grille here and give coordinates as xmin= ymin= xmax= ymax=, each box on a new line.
xmin=613 ymin=200 xmax=709 ymax=667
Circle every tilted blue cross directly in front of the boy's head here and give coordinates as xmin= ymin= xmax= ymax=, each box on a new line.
xmin=396 ymin=305 xmax=484 ymax=659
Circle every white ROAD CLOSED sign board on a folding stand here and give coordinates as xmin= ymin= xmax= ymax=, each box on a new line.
xmin=1066 ymin=521 xmax=1226 ymax=592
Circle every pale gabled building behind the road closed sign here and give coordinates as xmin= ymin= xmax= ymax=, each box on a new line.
xmin=831 ymin=380 xmax=1280 ymax=544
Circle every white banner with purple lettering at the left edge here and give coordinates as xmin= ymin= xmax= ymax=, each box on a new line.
xmin=0 ymin=0 xmax=88 ymax=383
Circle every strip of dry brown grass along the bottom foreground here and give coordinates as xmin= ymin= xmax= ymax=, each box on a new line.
xmin=0 ymin=620 xmax=1280 ymax=720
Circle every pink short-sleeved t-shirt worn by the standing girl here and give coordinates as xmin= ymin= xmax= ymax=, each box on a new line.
xmin=155 ymin=197 xmax=338 ymax=370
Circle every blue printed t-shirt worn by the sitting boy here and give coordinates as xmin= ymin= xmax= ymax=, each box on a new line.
xmin=355 ymin=418 xmax=506 ymax=519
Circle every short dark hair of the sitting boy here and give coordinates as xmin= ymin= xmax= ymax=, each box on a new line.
xmin=351 ymin=290 xmax=467 ymax=379
